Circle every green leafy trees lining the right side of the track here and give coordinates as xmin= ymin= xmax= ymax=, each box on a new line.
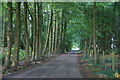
xmin=67 ymin=2 xmax=120 ymax=71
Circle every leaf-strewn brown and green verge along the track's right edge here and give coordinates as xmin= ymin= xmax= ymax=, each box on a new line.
xmin=78 ymin=54 xmax=117 ymax=78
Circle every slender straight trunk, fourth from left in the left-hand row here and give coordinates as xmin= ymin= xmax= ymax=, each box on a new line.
xmin=32 ymin=2 xmax=37 ymax=61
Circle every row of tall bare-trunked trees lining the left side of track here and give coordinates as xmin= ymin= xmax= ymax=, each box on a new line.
xmin=2 ymin=2 xmax=67 ymax=69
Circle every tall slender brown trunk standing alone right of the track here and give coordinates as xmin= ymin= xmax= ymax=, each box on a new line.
xmin=93 ymin=2 xmax=97 ymax=63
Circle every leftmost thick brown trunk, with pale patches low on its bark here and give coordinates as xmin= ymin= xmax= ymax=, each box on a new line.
xmin=6 ymin=2 xmax=12 ymax=68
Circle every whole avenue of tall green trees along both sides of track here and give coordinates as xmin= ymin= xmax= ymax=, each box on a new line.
xmin=2 ymin=2 xmax=120 ymax=74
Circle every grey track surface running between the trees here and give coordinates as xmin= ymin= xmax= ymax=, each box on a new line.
xmin=7 ymin=54 xmax=82 ymax=78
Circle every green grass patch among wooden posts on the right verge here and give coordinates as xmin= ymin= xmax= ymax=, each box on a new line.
xmin=83 ymin=55 xmax=118 ymax=78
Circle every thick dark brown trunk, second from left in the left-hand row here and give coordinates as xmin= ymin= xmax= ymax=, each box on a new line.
xmin=13 ymin=2 xmax=21 ymax=67
